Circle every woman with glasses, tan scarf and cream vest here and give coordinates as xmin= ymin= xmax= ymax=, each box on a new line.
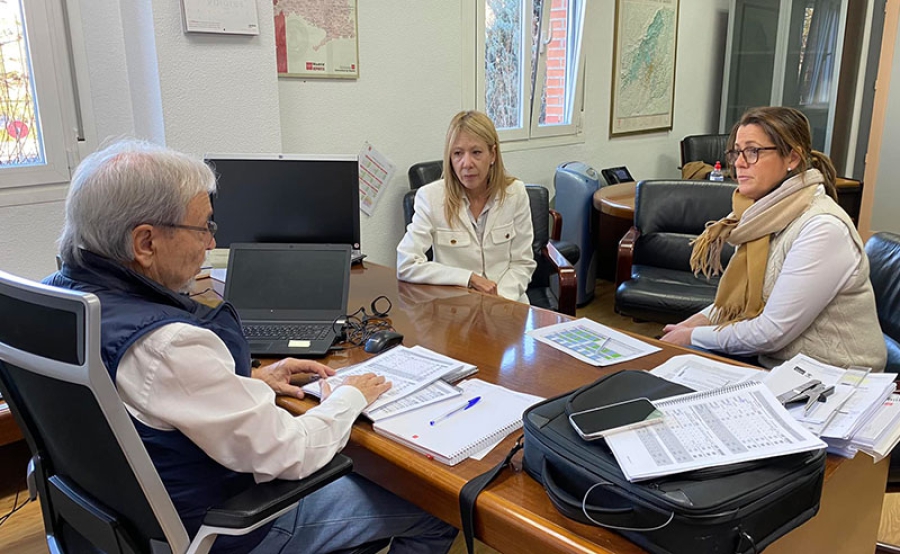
xmin=662 ymin=107 xmax=886 ymax=371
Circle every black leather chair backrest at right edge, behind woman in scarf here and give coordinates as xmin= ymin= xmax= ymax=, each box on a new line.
xmin=866 ymin=232 xmax=900 ymax=373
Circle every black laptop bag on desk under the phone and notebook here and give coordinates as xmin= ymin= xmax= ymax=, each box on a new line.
xmin=524 ymin=371 xmax=825 ymax=554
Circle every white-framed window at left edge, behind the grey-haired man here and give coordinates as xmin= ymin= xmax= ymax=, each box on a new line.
xmin=0 ymin=0 xmax=78 ymax=194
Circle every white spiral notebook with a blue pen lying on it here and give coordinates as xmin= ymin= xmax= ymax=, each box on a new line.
xmin=372 ymin=379 xmax=543 ymax=466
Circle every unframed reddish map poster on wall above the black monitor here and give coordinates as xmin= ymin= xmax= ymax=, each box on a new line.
xmin=274 ymin=0 xmax=359 ymax=79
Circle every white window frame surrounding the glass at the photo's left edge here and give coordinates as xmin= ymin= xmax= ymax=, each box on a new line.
xmin=0 ymin=0 xmax=85 ymax=206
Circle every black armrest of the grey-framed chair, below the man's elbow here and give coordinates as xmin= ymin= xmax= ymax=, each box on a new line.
xmin=203 ymin=454 xmax=353 ymax=529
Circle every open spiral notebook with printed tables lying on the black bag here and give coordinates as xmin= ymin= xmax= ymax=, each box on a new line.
xmin=605 ymin=382 xmax=825 ymax=482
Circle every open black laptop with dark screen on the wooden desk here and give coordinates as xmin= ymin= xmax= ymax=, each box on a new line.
xmin=225 ymin=243 xmax=350 ymax=357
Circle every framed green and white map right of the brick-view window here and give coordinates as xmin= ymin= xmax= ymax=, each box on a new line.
xmin=609 ymin=0 xmax=678 ymax=136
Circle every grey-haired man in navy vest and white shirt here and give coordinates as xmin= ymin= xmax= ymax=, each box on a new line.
xmin=44 ymin=141 xmax=456 ymax=554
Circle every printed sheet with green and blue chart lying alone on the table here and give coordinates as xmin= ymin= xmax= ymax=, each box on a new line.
xmin=526 ymin=318 xmax=661 ymax=366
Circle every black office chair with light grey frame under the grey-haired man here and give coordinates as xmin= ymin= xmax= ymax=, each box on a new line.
xmin=0 ymin=272 xmax=388 ymax=554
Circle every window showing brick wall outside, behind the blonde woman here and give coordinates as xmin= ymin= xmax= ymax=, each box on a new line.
xmin=476 ymin=0 xmax=585 ymax=141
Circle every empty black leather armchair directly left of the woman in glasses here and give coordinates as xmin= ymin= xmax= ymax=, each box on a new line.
xmin=615 ymin=180 xmax=735 ymax=323
